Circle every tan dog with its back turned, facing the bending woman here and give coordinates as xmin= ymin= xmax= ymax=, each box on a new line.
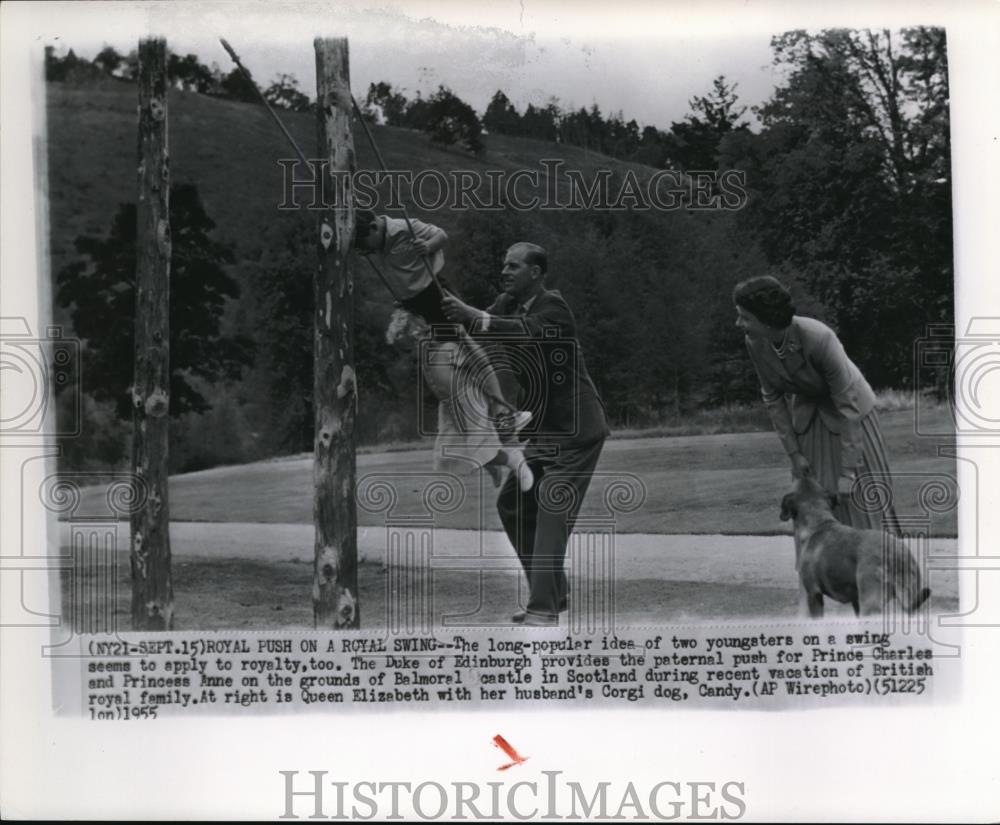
xmin=781 ymin=478 xmax=931 ymax=618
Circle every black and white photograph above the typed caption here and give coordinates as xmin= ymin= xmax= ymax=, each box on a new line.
xmin=33 ymin=10 xmax=958 ymax=630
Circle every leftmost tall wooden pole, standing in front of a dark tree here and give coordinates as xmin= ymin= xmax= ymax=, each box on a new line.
xmin=129 ymin=38 xmax=174 ymax=630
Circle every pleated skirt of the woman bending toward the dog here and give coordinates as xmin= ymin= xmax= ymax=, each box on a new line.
xmin=799 ymin=410 xmax=902 ymax=535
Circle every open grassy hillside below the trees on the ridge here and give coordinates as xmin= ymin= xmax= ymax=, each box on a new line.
xmin=47 ymin=82 xmax=676 ymax=284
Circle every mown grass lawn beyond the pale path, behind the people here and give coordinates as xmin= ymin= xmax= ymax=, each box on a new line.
xmin=78 ymin=407 xmax=957 ymax=536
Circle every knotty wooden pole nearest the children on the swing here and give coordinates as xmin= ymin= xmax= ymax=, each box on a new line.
xmin=313 ymin=38 xmax=361 ymax=628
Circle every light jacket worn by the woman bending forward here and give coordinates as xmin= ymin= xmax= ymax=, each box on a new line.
xmin=746 ymin=315 xmax=875 ymax=470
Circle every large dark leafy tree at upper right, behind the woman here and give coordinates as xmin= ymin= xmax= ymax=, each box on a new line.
xmin=720 ymin=29 xmax=953 ymax=385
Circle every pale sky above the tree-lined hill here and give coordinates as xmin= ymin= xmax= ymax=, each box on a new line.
xmin=25 ymin=0 xmax=944 ymax=128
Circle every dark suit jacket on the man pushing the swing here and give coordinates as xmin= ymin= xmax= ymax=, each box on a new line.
xmin=473 ymin=289 xmax=610 ymax=446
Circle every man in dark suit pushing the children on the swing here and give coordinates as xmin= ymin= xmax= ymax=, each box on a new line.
xmin=442 ymin=243 xmax=610 ymax=626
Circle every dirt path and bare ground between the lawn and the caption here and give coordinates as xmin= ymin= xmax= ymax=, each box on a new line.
xmin=60 ymin=522 xmax=958 ymax=630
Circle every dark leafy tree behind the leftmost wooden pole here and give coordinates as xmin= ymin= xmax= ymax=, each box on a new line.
xmin=56 ymin=184 xmax=252 ymax=419
